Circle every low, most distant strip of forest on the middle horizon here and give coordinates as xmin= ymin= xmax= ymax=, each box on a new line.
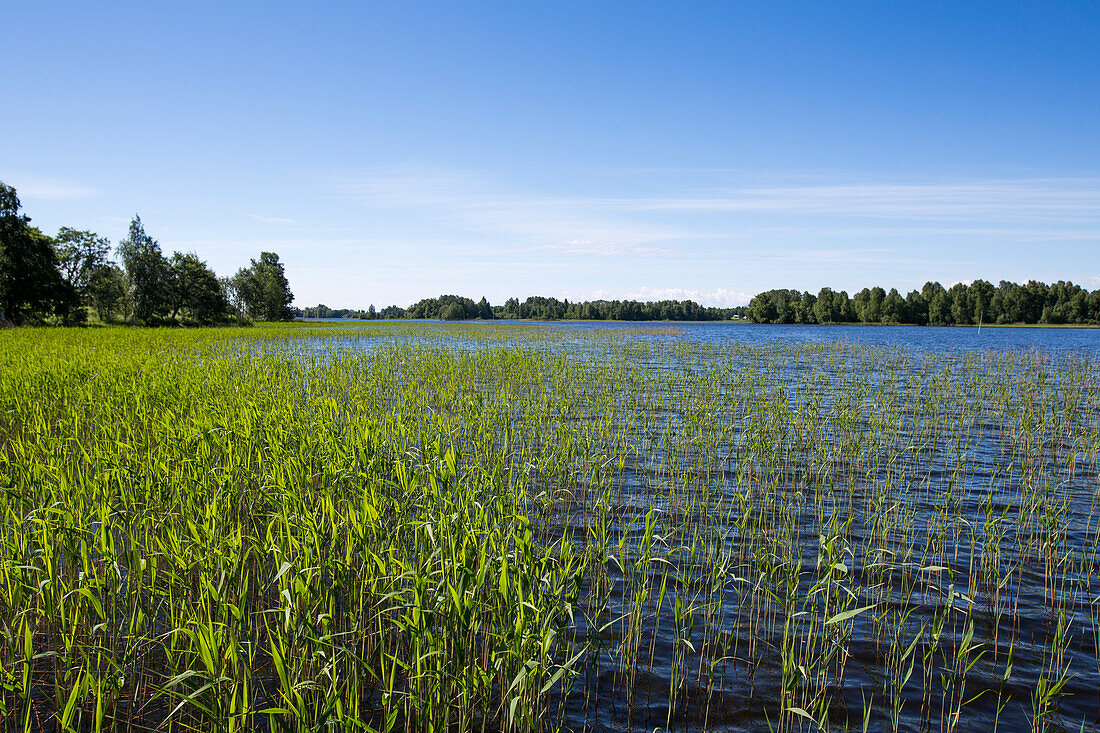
xmin=298 ymin=295 xmax=747 ymax=320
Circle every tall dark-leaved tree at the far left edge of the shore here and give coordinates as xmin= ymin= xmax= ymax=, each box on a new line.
xmin=0 ymin=182 xmax=72 ymax=325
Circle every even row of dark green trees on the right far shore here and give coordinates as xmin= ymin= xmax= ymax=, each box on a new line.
xmin=748 ymin=280 xmax=1100 ymax=326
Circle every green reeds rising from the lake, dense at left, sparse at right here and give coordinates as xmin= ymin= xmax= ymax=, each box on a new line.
xmin=0 ymin=324 xmax=1100 ymax=731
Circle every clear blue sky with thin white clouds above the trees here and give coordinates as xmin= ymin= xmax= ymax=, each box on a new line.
xmin=0 ymin=0 xmax=1100 ymax=308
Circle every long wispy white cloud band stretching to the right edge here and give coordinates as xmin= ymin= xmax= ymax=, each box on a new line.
xmin=331 ymin=164 xmax=1100 ymax=254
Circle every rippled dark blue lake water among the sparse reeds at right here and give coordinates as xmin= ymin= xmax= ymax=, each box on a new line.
xmin=294 ymin=321 xmax=1100 ymax=732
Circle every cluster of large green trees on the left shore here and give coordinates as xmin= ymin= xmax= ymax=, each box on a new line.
xmin=0 ymin=182 xmax=295 ymax=326
